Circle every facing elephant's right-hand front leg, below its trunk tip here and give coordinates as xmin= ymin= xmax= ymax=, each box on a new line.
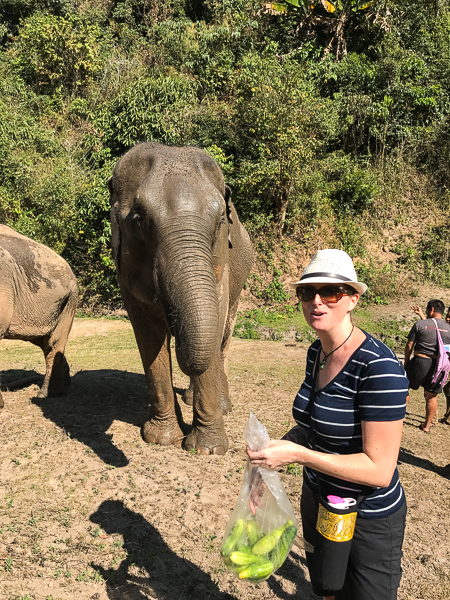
xmin=184 ymin=357 xmax=228 ymax=454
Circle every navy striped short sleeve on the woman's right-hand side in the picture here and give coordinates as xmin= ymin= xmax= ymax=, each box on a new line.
xmin=357 ymin=353 xmax=408 ymax=421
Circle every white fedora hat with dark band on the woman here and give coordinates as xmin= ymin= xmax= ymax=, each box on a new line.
xmin=290 ymin=249 xmax=367 ymax=294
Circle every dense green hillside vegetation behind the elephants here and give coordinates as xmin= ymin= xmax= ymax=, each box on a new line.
xmin=0 ymin=0 xmax=450 ymax=305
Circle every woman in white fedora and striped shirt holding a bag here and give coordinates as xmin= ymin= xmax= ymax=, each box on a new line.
xmin=247 ymin=250 xmax=408 ymax=600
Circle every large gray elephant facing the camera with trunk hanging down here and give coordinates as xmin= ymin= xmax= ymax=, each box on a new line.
xmin=108 ymin=142 xmax=253 ymax=454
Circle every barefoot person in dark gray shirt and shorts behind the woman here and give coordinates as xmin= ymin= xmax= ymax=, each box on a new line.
xmin=403 ymin=300 xmax=450 ymax=433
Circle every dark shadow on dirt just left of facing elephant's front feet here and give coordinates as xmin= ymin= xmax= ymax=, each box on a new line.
xmin=32 ymin=369 xmax=153 ymax=467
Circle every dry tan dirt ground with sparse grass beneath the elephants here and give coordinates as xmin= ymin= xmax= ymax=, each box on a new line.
xmin=0 ymin=308 xmax=450 ymax=600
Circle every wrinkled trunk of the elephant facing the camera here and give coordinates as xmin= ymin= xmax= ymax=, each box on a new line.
xmin=159 ymin=223 xmax=221 ymax=377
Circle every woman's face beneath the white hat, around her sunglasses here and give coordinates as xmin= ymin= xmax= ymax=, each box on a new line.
xmin=302 ymin=283 xmax=359 ymax=332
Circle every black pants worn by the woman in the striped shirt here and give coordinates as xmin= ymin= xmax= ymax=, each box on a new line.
xmin=301 ymin=484 xmax=406 ymax=600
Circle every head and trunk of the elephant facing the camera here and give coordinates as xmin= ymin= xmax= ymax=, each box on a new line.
xmin=108 ymin=142 xmax=232 ymax=376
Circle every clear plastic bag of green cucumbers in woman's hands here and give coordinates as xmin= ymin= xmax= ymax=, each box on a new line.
xmin=221 ymin=413 xmax=298 ymax=582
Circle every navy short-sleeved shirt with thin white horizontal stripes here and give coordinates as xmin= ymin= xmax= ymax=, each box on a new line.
xmin=293 ymin=332 xmax=408 ymax=519
